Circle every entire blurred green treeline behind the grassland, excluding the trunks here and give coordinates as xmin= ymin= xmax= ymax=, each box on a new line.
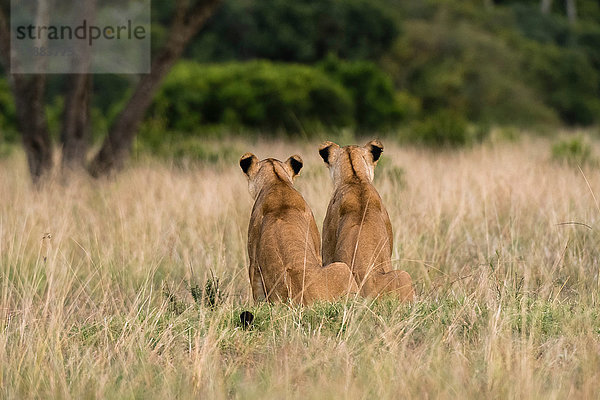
xmin=0 ymin=0 xmax=600 ymax=148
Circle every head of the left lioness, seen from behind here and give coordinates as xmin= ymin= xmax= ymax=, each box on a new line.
xmin=240 ymin=153 xmax=304 ymax=199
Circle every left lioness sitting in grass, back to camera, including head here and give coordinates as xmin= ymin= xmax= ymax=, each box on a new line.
xmin=240 ymin=153 xmax=358 ymax=305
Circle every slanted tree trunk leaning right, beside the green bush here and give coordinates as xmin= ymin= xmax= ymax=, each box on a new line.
xmin=89 ymin=0 xmax=220 ymax=177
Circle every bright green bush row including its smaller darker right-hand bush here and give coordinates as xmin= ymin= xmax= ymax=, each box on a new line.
xmin=145 ymin=57 xmax=405 ymax=133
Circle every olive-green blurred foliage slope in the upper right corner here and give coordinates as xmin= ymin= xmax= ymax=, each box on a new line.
xmin=382 ymin=1 xmax=600 ymax=125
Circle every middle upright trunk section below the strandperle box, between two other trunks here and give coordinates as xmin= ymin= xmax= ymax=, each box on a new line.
xmin=61 ymin=74 xmax=92 ymax=170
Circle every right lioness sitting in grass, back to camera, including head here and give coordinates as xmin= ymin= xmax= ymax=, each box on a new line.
xmin=319 ymin=140 xmax=414 ymax=301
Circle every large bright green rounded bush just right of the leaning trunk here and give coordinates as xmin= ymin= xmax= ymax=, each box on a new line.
xmin=150 ymin=61 xmax=353 ymax=132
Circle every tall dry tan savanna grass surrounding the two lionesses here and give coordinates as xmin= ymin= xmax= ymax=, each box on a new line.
xmin=0 ymin=134 xmax=600 ymax=399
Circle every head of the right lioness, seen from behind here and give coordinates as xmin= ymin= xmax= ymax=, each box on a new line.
xmin=319 ymin=140 xmax=383 ymax=185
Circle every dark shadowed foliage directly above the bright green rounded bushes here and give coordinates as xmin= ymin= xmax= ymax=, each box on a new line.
xmin=188 ymin=0 xmax=399 ymax=63
